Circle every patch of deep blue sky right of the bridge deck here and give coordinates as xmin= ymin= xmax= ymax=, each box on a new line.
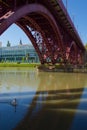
xmin=63 ymin=0 xmax=87 ymax=44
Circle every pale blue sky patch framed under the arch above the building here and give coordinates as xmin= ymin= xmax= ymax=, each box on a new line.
xmin=0 ymin=24 xmax=31 ymax=46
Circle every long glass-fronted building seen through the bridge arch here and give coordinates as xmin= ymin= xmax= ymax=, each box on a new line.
xmin=0 ymin=45 xmax=39 ymax=62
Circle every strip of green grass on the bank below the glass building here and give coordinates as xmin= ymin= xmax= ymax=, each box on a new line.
xmin=0 ymin=63 xmax=40 ymax=67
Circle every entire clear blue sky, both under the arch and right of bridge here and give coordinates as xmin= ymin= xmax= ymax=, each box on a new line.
xmin=0 ymin=0 xmax=87 ymax=46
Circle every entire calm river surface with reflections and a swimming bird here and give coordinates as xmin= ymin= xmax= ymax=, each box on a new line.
xmin=0 ymin=68 xmax=87 ymax=130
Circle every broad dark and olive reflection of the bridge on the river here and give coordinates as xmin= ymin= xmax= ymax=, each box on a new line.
xmin=15 ymin=73 xmax=85 ymax=130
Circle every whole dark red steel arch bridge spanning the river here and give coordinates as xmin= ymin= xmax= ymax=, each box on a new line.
xmin=0 ymin=0 xmax=85 ymax=64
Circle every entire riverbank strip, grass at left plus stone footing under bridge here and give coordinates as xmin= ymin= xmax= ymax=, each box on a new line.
xmin=0 ymin=62 xmax=87 ymax=73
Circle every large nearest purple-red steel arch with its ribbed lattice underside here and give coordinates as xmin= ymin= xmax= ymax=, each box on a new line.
xmin=0 ymin=3 xmax=63 ymax=63
